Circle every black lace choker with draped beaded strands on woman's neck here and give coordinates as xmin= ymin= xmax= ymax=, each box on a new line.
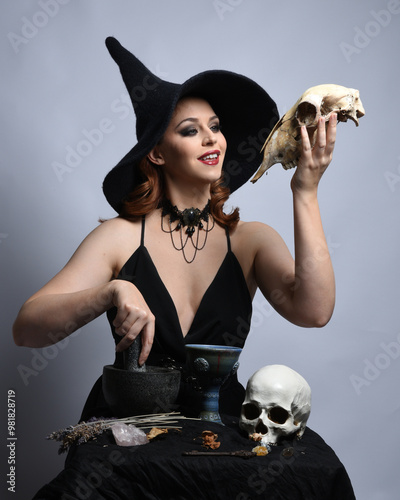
xmin=159 ymin=199 xmax=215 ymax=264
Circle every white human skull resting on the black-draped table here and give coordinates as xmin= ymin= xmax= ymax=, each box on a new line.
xmin=239 ymin=365 xmax=311 ymax=445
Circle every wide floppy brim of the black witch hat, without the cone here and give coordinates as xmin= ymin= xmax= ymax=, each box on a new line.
xmin=103 ymin=47 xmax=279 ymax=213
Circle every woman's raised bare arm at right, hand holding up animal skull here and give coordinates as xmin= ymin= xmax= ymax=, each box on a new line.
xmin=254 ymin=115 xmax=337 ymax=327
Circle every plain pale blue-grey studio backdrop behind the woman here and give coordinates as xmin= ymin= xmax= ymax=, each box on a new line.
xmin=0 ymin=0 xmax=400 ymax=500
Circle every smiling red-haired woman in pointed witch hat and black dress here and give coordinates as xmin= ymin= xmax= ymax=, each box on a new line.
xmin=14 ymin=38 xmax=354 ymax=500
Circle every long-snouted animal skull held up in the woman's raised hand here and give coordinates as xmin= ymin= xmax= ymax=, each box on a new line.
xmin=251 ymin=84 xmax=365 ymax=182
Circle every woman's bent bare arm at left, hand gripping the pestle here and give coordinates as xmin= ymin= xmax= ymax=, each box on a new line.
xmin=13 ymin=219 xmax=154 ymax=363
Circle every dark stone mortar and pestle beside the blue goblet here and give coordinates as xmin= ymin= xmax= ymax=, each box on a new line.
xmin=102 ymin=335 xmax=181 ymax=418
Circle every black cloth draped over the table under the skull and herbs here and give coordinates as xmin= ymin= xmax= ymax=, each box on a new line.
xmin=34 ymin=416 xmax=355 ymax=500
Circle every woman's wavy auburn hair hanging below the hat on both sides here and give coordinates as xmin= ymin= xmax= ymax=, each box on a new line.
xmin=120 ymin=157 xmax=240 ymax=229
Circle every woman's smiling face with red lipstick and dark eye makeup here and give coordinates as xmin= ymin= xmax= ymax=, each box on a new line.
xmin=148 ymin=97 xmax=226 ymax=190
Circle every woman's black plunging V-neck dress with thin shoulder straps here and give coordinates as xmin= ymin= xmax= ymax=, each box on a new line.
xmin=82 ymin=218 xmax=252 ymax=419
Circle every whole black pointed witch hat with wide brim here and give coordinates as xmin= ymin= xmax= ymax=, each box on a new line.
xmin=103 ymin=37 xmax=279 ymax=213
